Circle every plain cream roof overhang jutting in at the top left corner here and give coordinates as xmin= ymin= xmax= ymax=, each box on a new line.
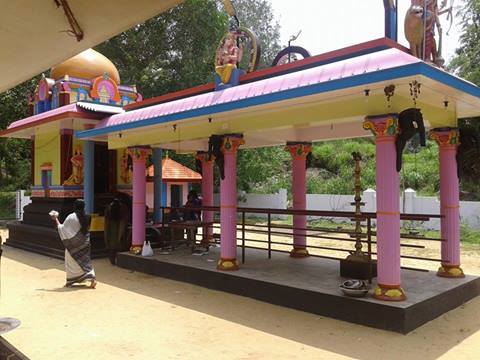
xmin=0 ymin=0 xmax=182 ymax=92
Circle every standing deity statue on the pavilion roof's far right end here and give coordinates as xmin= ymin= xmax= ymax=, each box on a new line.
xmin=405 ymin=0 xmax=452 ymax=66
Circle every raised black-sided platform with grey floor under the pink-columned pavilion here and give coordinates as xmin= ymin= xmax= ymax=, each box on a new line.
xmin=117 ymin=248 xmax=480 ymax=334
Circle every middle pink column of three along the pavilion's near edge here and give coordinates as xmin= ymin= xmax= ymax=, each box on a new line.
xmin=217 ymin=135 xmax=244 ymax=270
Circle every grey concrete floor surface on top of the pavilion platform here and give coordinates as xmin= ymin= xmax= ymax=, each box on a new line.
xmin=124 ymin=247 xmax=478 ymax=308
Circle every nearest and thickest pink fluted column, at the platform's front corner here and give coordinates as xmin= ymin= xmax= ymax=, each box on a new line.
xmin=363 ymin=114 xmax=406 ymax=301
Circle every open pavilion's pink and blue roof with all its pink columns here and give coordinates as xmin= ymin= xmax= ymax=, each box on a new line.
xmin=76 ymin=40 xmax=480 ymax=301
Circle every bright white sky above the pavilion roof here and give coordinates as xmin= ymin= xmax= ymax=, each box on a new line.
xmin=270 ymin=0 xmax=463 ymax=62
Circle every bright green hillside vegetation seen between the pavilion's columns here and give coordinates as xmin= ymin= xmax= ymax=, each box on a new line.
xmin=238 ymin=139 xmax=439 ymax=195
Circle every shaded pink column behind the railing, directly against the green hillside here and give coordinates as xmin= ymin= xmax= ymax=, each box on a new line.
xmin=285 ymin=142 xmax=312 ymax=258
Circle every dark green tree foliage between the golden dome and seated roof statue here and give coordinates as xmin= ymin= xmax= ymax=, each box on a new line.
xmin=96 ymin=0 xmax=227 ymax=98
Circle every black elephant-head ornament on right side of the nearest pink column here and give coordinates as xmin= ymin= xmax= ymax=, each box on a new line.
xmin=395 ymin=108 xmax=426 ymax=172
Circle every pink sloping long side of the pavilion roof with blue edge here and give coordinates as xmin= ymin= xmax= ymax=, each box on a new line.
xmin=79 ymin=49 xmax=421 ymax=138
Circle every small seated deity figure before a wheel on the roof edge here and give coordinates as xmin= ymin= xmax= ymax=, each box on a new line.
xmin=215 ymin=31 xmax=241 ymax=84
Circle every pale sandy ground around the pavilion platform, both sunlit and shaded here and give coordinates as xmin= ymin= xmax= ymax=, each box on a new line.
xmin=0 ymin=229 xmax=480 ymax=360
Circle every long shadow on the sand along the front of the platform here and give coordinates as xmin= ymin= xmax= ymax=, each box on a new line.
xmin=3 ymin=247 xmax=480 ymax=360
